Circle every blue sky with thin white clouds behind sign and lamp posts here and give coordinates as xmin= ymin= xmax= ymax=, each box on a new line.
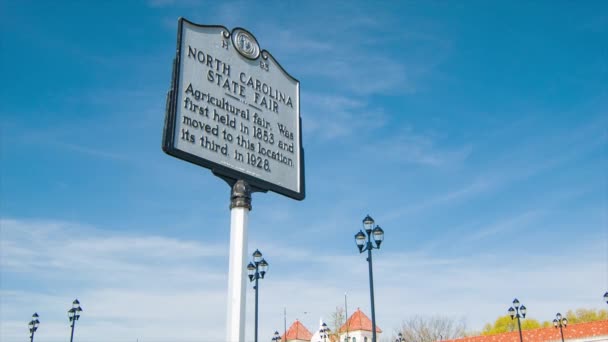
xmin=0 ymin=0 xmax=608 ymax=342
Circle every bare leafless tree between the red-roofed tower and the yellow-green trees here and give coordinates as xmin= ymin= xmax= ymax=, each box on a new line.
xmin=399 ymin=316 xmax=466 ymax=342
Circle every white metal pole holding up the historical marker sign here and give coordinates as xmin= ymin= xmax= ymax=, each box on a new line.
xmin=226 ymin=180 xmax=251 ymax=342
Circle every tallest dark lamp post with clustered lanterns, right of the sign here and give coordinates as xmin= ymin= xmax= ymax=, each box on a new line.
xmin=355 ymin=215 xmax=384 ymax=342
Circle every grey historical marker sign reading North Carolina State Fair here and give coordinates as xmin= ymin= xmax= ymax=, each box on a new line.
xmin=163 ymin=18 xmax=305 ymax=200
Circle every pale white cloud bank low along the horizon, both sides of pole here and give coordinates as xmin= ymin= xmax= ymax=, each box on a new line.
xmin=0 ymin=219 xmax=603 ymax=342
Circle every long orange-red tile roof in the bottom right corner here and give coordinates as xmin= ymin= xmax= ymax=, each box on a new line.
xmin=441 ymin=320 xmax=608 ymax=342
